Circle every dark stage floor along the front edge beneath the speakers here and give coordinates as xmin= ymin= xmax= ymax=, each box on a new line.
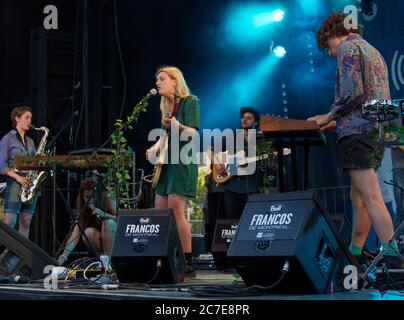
xmin=0 ymin=270 xmax=404 ymax=302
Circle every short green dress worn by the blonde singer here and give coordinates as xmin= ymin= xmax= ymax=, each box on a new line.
xmin=156 ymin=95 xmax=200 ymax=198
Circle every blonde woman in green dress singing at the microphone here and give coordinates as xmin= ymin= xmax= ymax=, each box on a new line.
xmin=146 ymin=67 xmax=200 ymax=276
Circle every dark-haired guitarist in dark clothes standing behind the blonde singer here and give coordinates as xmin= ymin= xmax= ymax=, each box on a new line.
xmin=210 ymin=107 xmax=262 ymax=219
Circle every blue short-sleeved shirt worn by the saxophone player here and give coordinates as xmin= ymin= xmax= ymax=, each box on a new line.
xmin=0 ymin=130 xmax=36 ymax=175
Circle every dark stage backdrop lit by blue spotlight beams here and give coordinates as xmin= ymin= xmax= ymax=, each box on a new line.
xmin=0 ymin=0 xmax=404 ymax=251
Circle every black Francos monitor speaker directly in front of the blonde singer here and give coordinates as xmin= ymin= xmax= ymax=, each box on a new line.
xmin=111 ymin=209 xmax=185 ymax=284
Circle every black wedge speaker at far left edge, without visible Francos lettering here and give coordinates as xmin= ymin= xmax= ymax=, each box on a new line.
xmin=0 ymin=222 xmax=57 ymax=280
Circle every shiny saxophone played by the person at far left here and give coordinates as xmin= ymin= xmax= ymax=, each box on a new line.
xmin=19 ymin=126 xmax=49 ymax=203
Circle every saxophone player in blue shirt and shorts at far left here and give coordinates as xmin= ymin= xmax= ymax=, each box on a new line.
xmin=0 ymin=106 xmax=37 ymax=238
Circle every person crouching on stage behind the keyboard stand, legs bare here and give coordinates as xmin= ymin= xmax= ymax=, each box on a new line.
xmin=58 ymin=178 xmax=116 ymax=265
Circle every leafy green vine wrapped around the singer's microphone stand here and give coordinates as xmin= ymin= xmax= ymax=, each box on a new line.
xmin=103 ymin=99 xmax=149 ymax=208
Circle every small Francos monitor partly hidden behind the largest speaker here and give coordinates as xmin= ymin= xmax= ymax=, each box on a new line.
xmin=211 ymin=219 xmax=239 ymax=271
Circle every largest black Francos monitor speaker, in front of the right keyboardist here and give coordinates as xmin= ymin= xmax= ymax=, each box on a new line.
xmin=227 ymin=192 xmax=356 ymax=293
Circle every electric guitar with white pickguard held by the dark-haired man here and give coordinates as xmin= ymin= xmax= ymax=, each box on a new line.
xmin=212 ymin=148 xmax=291 ymax=183
